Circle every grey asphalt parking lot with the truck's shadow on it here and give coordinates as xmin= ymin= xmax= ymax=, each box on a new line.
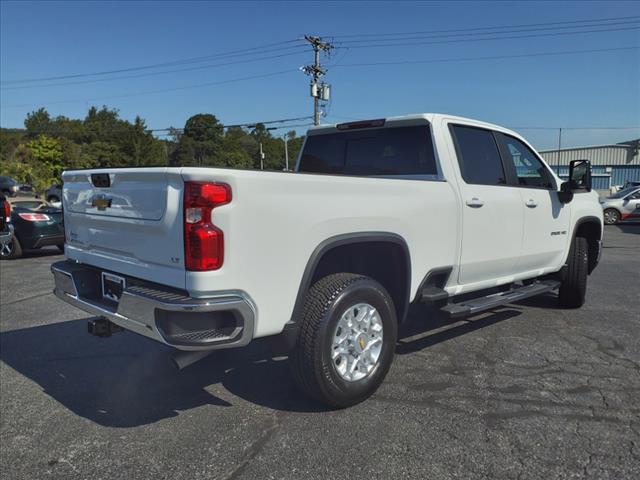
xmin=0 ymin=224 xmax=640 ymax=480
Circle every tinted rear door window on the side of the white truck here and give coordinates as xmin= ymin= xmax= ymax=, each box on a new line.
xmin=451 ymin=125 xmax=507 ymax=185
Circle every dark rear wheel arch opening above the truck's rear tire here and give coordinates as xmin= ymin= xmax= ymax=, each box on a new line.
xmin=291 ymin=232 xmax=411 ymax=323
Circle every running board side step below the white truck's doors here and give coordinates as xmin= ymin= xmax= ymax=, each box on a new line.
xmin=440 ymin=280 xmax=560 ymax=318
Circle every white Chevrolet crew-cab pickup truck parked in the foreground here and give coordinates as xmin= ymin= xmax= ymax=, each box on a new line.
xmin=52 ymin=114 xmax=603 ymax=407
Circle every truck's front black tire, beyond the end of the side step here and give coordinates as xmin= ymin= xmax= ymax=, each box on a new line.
xmin=558 ymin=237 xmax=589 ymax=308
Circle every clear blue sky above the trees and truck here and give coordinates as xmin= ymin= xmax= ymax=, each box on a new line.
xmin=0 ymin=1 xmax=640 ymax=149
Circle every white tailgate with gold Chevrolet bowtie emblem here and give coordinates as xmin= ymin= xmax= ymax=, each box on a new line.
xmin=63 ymin=168 xmax=185 ymax=288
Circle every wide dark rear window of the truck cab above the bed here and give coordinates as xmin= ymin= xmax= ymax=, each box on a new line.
xmin=298 ymin=126 xmax=437 ymax=176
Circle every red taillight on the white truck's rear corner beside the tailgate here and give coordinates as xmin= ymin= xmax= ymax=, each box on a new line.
xmin=184 ymin=182 xmax=231 ymax=271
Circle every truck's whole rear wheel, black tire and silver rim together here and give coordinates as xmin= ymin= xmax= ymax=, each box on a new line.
xmin=291 ymin=273 xmax=397 ymax=408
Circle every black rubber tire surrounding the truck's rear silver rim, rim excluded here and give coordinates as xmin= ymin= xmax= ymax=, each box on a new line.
xmin=290 ymin=273 xmax=398 ymax=408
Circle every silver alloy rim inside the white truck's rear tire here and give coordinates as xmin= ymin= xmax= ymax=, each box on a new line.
xmin=331 ymin=303 xmax=383 ymax=382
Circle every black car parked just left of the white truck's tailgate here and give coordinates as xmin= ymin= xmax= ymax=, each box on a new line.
xmin=0 ymin=200 xmax=64 ymax=259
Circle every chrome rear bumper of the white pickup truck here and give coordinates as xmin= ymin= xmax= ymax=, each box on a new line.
xmin=51 ymin=261 xmax=255 ymax=350
